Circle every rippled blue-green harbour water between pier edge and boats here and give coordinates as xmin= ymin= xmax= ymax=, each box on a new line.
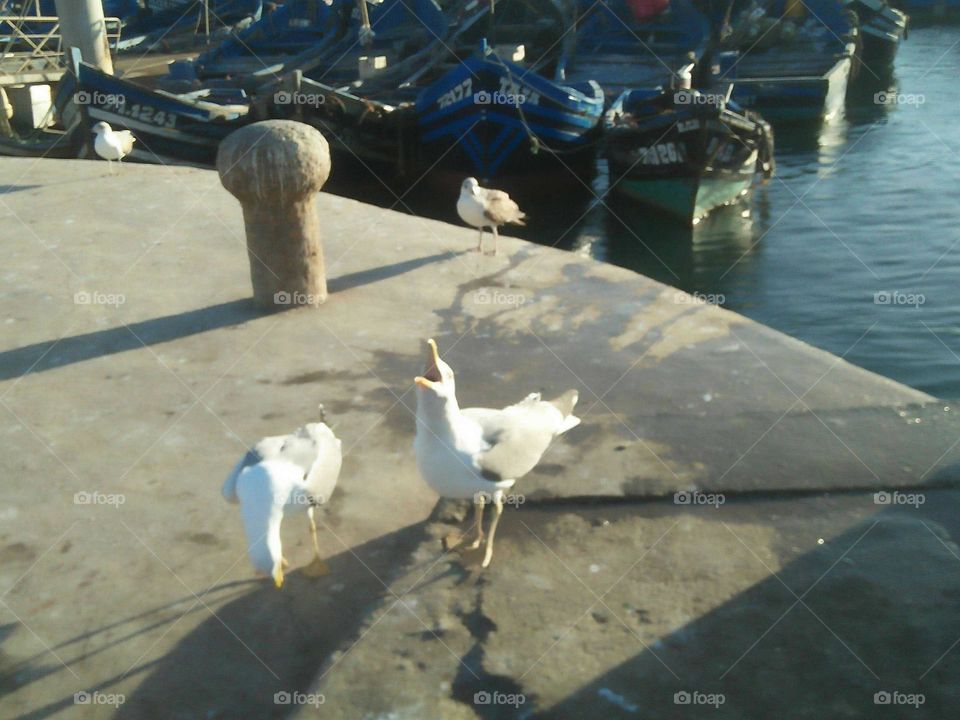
xmin=332 ymin=26 xmax=960 ymax=398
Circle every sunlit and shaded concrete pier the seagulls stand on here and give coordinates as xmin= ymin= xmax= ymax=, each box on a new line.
xmin=0 ymin=159 xmax=960 ymax=719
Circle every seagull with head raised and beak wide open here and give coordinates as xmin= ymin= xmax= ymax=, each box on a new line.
xmin=414 ymin=340 xmax=580 ymax=567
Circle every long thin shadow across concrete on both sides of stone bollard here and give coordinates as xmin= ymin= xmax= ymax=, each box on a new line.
xmin=0 ymin=251 xmax=465 ymax=380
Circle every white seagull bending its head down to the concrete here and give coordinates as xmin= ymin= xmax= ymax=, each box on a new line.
xmin=221 ymin=414 xmax=342 ymax=588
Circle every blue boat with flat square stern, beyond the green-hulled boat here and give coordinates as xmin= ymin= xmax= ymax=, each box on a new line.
xmin=701 ymin=0 xmax=857 ymax=123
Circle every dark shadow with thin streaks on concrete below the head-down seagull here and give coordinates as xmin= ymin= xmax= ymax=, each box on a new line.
xmin=3 ymin=523 xmax=425 ymax=720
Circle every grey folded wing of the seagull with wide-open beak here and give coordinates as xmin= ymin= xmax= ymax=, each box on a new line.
xmin=461 ymin=394 xmax=564 ymax=482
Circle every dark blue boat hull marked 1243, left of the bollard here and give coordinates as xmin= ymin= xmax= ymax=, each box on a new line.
xmin=78 ymin=63 xmax=253 ymax=167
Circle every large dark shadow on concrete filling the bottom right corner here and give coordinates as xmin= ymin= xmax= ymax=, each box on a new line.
xmin=540 ymin=494 xmax=960 ymax=720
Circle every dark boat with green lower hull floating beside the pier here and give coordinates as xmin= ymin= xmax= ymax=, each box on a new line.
xmin=604 ymin=83 xmax=774 ymax=225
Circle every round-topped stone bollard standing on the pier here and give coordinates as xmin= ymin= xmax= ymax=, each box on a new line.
xmin=217 ymin=120 xmax=330 ymax=310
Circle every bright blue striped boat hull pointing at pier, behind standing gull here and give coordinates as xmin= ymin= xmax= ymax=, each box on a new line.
xmin=415 ymin=53 xmax=603 ymax=182
